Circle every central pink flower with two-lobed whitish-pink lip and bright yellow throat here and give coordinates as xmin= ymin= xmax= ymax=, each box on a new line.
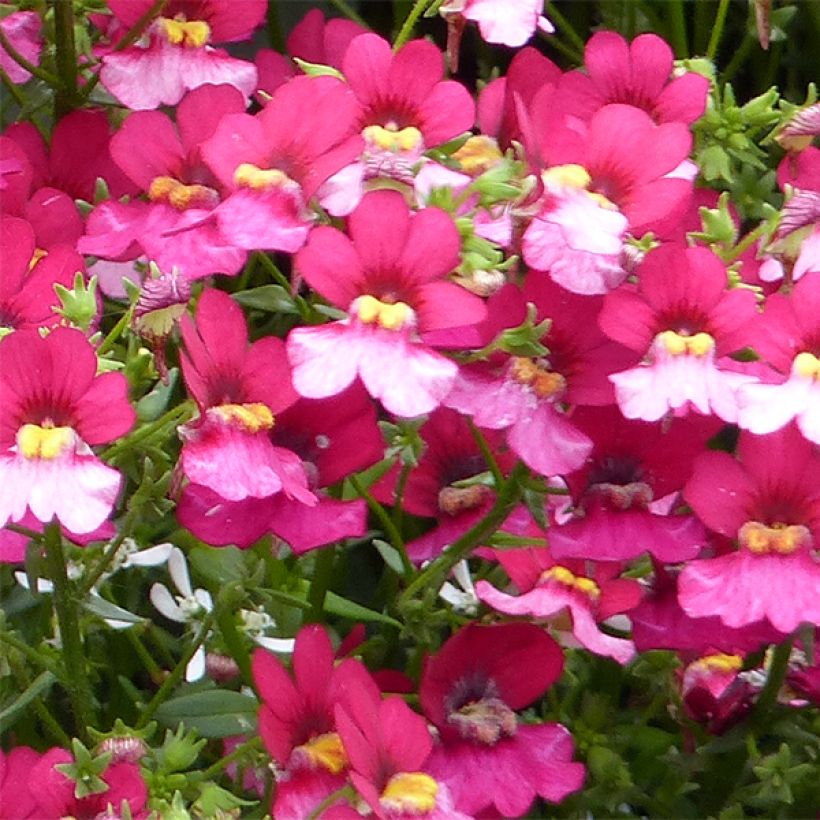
xmin=287 ymin=191 xmax=485 ymax=416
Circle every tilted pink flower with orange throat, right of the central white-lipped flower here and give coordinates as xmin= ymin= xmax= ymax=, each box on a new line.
xmin=445 ymin=275 xmax=634 ymax=476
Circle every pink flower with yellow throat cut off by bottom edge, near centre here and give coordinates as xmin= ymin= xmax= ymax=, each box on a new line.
xmin=335 ymin=687 xmax=470 ymax=820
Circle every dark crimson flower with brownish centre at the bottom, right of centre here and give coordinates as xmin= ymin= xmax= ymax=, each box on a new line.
xmin=419 ymin=623 xmax=584 ymax=817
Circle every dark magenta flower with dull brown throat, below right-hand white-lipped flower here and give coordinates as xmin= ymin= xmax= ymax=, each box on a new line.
xmin=549 ymin=406 xmax=721 ymax=562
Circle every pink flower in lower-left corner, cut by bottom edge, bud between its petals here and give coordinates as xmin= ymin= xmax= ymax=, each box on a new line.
xmin=28 ymin=748 xmax=148 ymax=817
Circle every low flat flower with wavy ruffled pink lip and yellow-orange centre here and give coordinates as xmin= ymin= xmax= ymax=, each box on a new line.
xmin=476 ymin=549 xmax=640 ymax=664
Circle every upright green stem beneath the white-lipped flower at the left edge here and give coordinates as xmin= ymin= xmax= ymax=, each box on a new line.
xmin=45 ymin=522 xmax=95 ymax=743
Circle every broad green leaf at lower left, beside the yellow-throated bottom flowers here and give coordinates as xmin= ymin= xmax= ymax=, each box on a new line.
xmin=157 ymin=689 xmax=259 ymax=738
